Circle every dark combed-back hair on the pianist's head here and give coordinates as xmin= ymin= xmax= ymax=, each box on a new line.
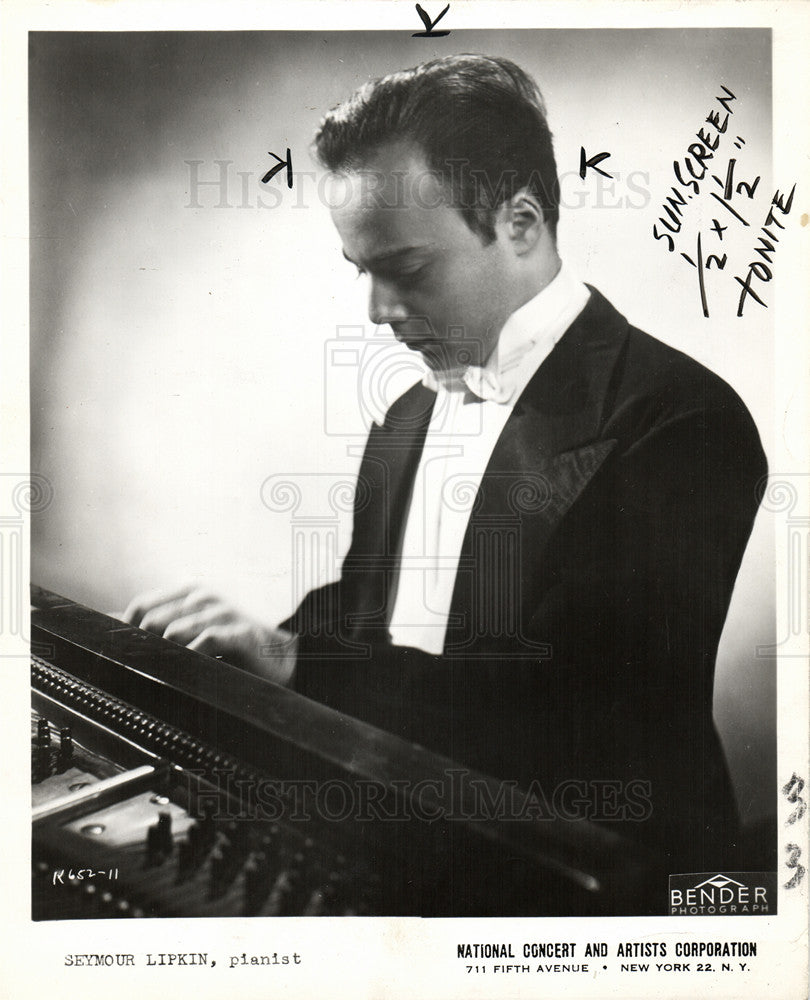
xmin=313 ymin=55 xmax=560 ymax=244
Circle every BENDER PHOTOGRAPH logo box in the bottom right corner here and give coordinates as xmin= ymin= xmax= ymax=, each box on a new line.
xmin=669 ymin=872 xmax=776 ymax=917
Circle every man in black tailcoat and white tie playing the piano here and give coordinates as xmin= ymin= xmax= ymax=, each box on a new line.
xmin=127 ymin=50 xmax=766 ymax=872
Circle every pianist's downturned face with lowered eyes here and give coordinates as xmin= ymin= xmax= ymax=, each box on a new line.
xmin=331 ymin=144 xmax=513 ymax=371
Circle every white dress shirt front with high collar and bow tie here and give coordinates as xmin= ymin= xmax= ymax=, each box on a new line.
xmin=389 ymin=265 xmax=590 ymax=656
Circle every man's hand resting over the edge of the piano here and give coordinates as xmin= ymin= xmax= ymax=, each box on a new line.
xmin=123 ymin=586 xmax=298 ymax=684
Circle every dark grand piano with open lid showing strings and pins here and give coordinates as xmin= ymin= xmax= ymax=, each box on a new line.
xmin=31 ymin=587 xmax=666 ymax=920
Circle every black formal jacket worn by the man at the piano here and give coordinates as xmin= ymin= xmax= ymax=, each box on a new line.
xmin=284 ymin=289 xmax=766 ymax=871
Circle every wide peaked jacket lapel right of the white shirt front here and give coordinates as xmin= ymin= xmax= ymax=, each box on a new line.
xmin=445 ymin=289 xmax=628 ymax=658
